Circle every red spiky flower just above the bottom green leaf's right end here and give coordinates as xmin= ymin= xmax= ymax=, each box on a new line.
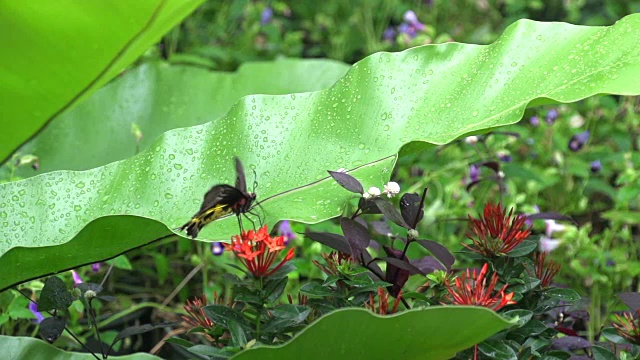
xmin=446 ymin=263 xmax=516 ymax=311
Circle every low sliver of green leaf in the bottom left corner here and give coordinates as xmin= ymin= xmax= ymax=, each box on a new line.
xmin=0 ymin=335 xmax=160 ymax=360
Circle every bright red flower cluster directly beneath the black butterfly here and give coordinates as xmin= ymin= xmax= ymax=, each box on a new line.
xmin=224 ymin=225 xmax=294 ymax=277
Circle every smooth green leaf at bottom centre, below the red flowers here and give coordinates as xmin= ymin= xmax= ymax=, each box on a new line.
xmin=233 ymin=306 xmax=510 ymax=360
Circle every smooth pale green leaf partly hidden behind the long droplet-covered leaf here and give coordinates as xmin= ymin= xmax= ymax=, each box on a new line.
xmin=3 ymin=59 xmax=349 ymax=178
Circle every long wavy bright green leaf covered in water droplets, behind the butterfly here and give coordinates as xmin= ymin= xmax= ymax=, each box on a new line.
xmin=0 ymin=15 xmax=640 ymax=289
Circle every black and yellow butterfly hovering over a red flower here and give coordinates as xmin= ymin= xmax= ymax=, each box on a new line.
xmin=180 ymin=157 xmax=256 ymax=238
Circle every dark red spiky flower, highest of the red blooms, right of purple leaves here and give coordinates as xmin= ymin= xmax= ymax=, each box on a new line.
xmin=462 ymin=203 xmax=531 ymax=257
